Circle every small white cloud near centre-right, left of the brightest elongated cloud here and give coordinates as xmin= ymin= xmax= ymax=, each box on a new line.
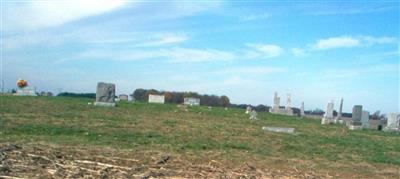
xmin=246 ymin=44 xmax=283 ymax=58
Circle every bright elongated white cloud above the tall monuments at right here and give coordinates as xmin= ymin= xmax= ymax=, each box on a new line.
xmin=312 ymin=36 xmax=360 ymax=50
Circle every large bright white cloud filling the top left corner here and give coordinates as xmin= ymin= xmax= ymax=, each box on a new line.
xmin=3 ymin=0 xmax=125 ymax=30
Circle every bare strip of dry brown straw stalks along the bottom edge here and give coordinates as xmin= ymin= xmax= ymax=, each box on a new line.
xmin=0 ymin=144 xmax=332 ymax=179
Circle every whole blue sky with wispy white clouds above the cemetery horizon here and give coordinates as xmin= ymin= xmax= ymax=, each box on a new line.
xmin=1 ymin=0 xmax=400 ymax=113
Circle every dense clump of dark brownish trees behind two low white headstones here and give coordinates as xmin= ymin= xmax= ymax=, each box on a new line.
xmin=131 ymin=88 xmax=230 ymax=107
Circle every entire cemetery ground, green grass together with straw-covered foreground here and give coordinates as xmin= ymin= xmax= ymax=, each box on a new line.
xmin=0 ymin=96 xmax=400 ymax=178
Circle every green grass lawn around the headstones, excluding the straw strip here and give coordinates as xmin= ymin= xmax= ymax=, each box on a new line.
xmin=0 ymin=96 xmax=400 ymax=177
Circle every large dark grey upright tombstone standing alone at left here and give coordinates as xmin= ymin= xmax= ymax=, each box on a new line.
xmin=94 ymin=82 xmax=115 ymax=106
